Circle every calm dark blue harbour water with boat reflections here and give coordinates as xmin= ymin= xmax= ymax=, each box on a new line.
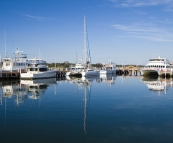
xmin=0 ymin=76 xmax=173 ymax=143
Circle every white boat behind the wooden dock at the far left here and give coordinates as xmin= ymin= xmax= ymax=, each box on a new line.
xmin=2 ymin=49 xmax=28 ymax=72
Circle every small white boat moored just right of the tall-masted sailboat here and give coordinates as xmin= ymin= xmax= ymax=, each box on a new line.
xmin=100 ymin=58 xmax=116 ymax=74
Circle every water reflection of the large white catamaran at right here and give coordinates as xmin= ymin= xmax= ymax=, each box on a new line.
xmin=141 ymin=76 xmax=173 ymax=94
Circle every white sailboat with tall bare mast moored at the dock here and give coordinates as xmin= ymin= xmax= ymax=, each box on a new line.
xmin=81 ymin=16 xmax=99 ymax=77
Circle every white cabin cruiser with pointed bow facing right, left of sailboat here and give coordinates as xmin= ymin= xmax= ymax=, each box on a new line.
xmin=20 ymin=58 xmax=56 ymax=79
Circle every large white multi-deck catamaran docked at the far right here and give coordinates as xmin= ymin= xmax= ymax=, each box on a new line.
xmin=141 ymin=56 xmax=173 ymax=75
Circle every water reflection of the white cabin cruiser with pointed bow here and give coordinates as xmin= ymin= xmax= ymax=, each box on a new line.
xmin=21 ymin=78 xmax=56 ymax=99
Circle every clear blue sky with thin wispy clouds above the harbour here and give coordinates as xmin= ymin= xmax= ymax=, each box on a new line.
xmin=0 ymin=0 xmax=173 ymax=64
